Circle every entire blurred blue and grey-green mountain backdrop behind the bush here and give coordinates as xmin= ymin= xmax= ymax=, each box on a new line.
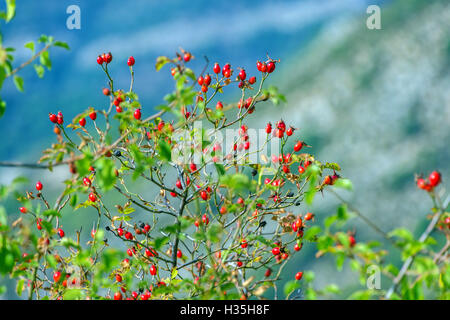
xmin=0 ymin=0 xmax=450 ymax=300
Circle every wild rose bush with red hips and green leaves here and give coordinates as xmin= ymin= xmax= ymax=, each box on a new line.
xmin=0 ymin=50 xmax=450 ymax=300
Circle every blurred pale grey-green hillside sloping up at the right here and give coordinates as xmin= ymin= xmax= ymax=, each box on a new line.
xmin=264 ymin=0 xmax=450 ymax=296
